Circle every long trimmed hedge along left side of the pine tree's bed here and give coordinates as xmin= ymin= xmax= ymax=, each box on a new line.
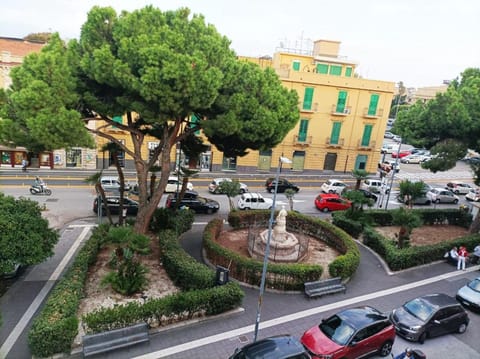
xmin=28 ymin=226 xmax=108 ymax=357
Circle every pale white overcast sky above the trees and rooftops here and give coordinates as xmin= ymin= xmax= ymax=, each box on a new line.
xmin=0 ymin=0 xmax=480 ymax=87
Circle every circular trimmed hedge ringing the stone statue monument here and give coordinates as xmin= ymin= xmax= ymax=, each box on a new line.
xmin=203 ymin=211 xmax=360 ymax=290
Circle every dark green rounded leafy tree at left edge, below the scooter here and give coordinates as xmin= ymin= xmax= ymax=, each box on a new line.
xmin=0 ymin=192 xmax=58 ymax=273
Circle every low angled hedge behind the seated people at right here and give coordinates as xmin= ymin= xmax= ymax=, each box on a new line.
xmin=363 ymin=227 xmax=480 ymax=271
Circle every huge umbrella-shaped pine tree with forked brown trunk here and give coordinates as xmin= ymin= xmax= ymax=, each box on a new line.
xmin=0 ymin=6 xmax=299 ymax=236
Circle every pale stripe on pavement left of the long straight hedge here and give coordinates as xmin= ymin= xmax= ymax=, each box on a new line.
xmin=0 ymin=225 xmax=91 ymax=358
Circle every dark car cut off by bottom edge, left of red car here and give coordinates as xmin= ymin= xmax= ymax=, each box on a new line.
xmin=229 ymin=335 xmax=311 ymax=359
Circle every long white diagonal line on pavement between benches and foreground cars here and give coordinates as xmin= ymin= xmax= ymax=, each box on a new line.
xmin=133 ymin=265 xmax=480 ymax=359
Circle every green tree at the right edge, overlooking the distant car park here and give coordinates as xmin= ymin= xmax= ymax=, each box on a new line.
xmin=394 ymin=68 xmax=480 ymax=172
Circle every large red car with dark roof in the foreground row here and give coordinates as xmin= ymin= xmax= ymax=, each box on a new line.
xmin=300 ymin=306 xmax=395 ymax=359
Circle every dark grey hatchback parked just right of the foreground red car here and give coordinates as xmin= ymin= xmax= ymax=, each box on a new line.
xmin=390 ymin=293 xmax=470 ymax=343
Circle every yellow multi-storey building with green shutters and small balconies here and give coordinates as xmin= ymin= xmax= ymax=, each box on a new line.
xmin=212 ymin=40 xmax=395 ymax=173
